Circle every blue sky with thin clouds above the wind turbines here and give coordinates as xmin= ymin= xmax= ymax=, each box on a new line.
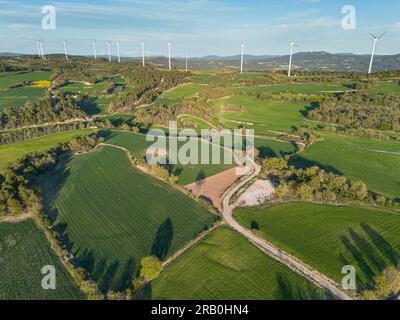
xmin=0 ymin=0 xmax=400 ymax=56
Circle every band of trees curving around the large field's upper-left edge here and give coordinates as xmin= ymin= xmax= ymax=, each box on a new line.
xmin=0 ymin=134 xmax=102 ymax=216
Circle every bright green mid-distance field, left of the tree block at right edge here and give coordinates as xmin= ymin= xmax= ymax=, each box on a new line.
xmin=214 ymin=96 xmax=305 ymax=135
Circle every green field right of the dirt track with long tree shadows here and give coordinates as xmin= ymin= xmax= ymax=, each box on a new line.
xmin=235 ymin=203 xmax=400 ymax=287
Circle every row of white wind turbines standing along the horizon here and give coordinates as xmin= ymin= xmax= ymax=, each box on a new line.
xmin=36 ymin=31 xmax=387 ymax=77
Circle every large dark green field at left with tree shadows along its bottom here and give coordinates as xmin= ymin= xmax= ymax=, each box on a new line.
xmin=40 ymin=147 xmax=215 ymax=291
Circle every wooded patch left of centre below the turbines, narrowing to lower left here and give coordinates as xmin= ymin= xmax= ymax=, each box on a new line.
xmin=110 ymin=66 xmax=190 ymax=112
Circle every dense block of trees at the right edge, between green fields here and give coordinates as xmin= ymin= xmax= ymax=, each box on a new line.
xmin=307 ymin=93 xmax=400 ymax=132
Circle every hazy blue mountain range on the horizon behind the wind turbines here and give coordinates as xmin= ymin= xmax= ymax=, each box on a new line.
xmin=0 ymin=51 xmax=400 ymax=72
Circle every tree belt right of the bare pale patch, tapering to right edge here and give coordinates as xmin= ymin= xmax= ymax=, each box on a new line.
xmin=263 ymin=158 xmax=400 ymax=210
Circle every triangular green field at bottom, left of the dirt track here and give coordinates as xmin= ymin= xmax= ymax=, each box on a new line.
xmin=138 ymin=227 xmax=327 ymax=300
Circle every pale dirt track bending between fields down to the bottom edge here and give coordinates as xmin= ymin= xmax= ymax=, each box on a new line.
xmin=222 ymin=164 xmax=353 ymax=300
